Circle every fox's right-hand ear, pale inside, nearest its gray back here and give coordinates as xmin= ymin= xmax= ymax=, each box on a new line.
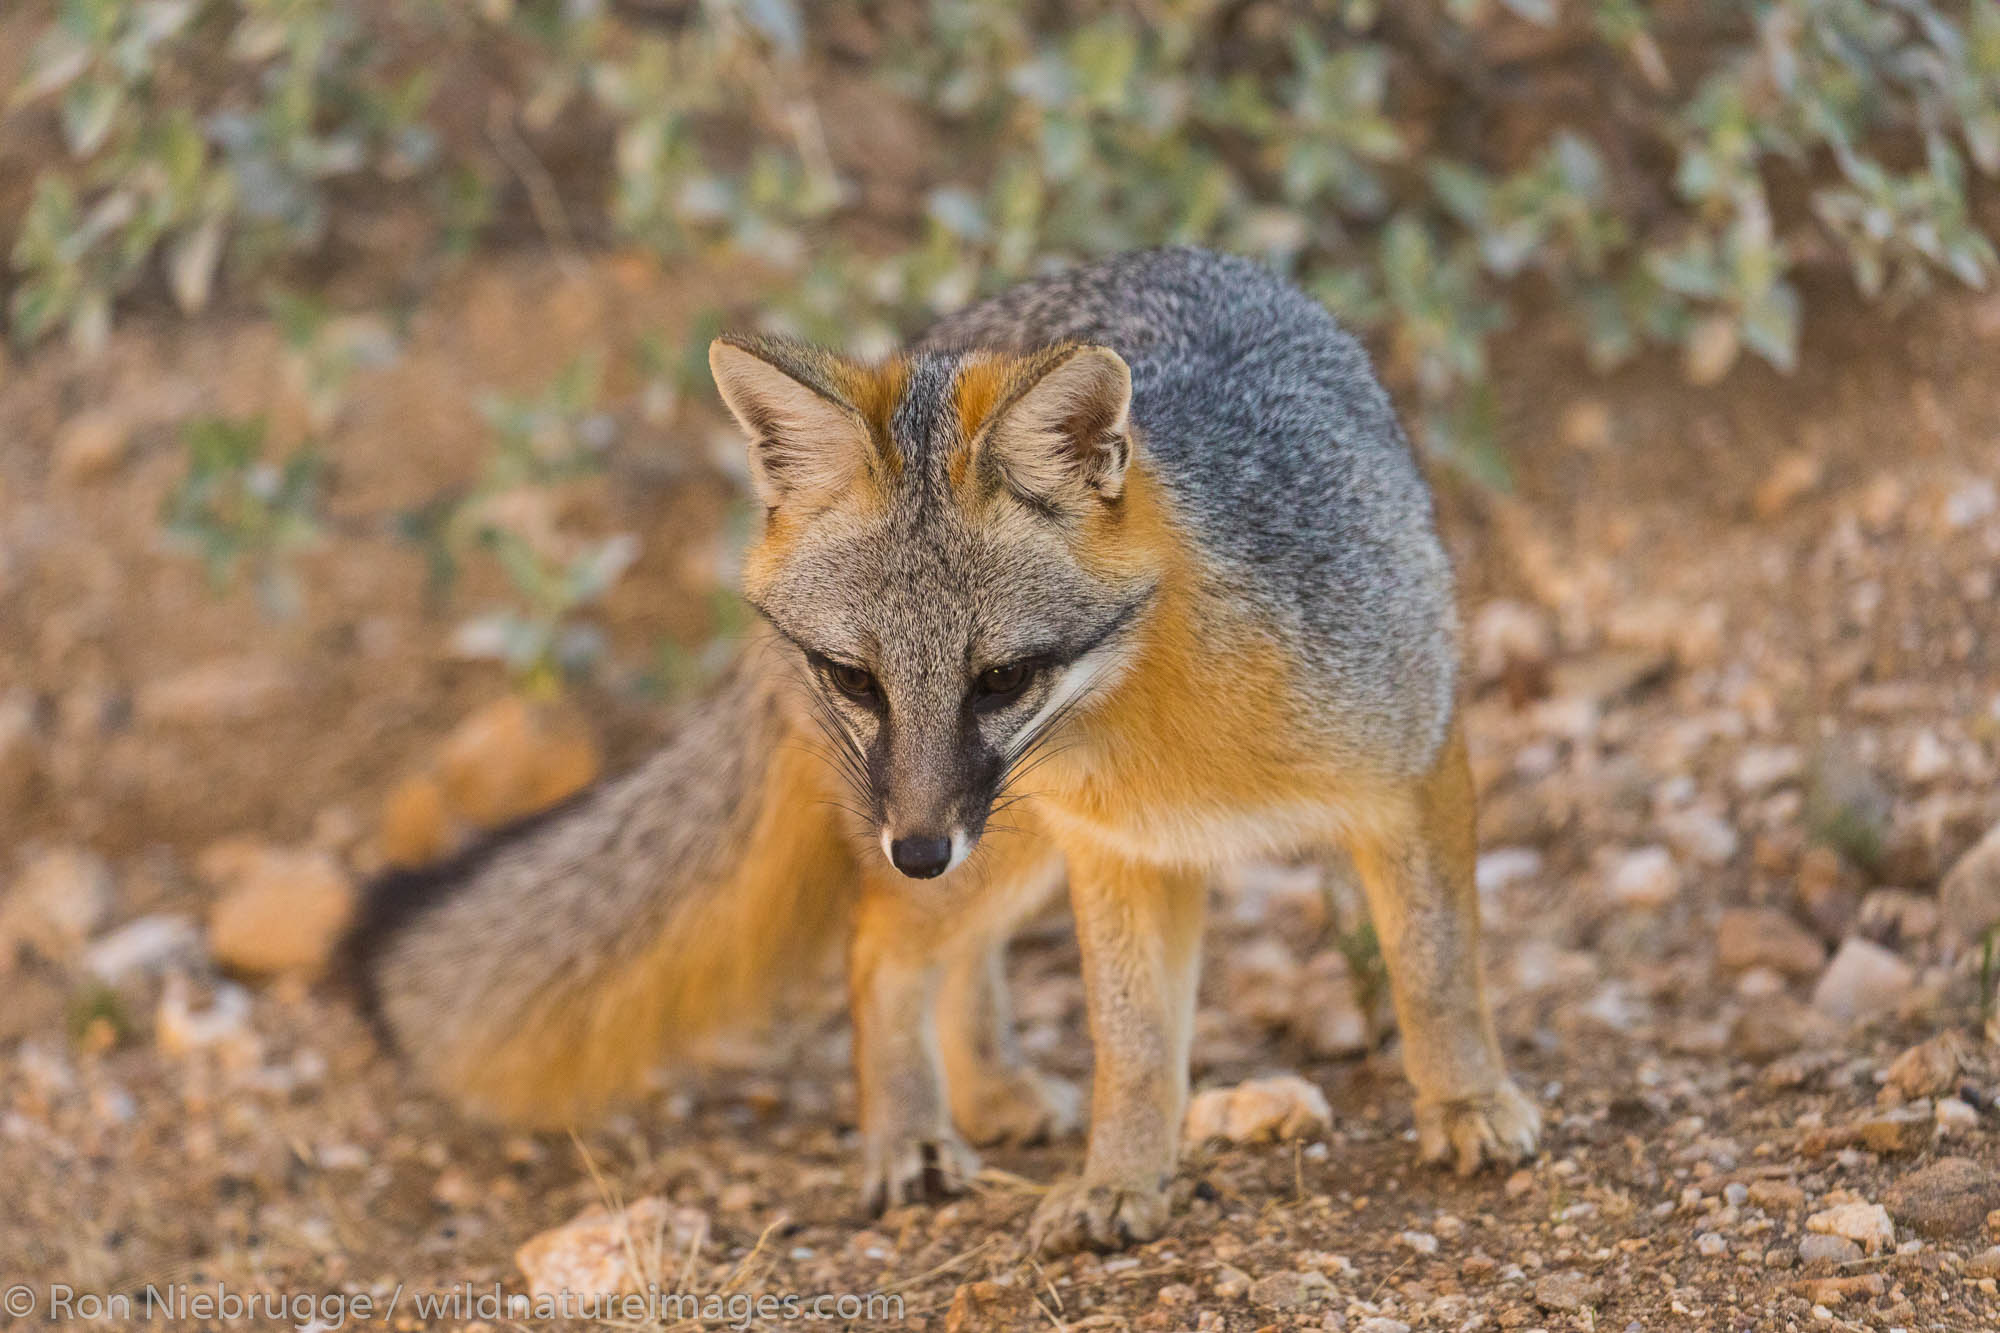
xmin=986 ymin=346 xmax=1132 ymax=508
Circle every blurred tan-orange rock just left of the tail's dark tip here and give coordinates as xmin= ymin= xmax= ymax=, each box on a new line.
xmin=200 ymin=839 xmax=354 ymax=977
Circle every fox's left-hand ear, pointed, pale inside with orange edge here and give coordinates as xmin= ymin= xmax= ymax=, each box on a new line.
xmin=708 ymin=338 xmax=874 ymax=508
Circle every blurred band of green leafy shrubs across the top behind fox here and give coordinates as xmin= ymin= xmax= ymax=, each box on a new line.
xmin=12 ymin=0 xmax=2000 ymax=470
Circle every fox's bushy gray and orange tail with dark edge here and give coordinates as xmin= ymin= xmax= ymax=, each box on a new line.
xmin=352 ymin=654 xmax=854 ymax=1125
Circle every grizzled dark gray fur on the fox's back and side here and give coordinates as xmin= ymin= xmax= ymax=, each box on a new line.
xmin=916 ymin=248 xmax=1458 ymax=763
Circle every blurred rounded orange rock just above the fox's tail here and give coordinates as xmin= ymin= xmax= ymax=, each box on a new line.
xmin=438 ymin=697 xmax=602 ymax=829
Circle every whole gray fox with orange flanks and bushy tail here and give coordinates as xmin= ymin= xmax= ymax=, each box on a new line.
xmin=360 ymin=248 xmax=1540 ymax=1251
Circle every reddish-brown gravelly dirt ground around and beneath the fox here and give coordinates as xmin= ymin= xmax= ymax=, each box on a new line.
xmin=0 ymin=256 xmax=2000 ymax=1333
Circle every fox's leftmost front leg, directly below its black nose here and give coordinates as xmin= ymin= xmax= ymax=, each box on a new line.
xmin=848 ymin=889 xmax=980 ymax=1213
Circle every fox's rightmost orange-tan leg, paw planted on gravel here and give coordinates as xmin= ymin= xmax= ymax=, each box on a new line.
xmin=1348 ymin=727 xmax=1542 ymax=1175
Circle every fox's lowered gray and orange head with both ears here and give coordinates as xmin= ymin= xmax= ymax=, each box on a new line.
xmin=708 ymin=338 xmax=1160 ymax=879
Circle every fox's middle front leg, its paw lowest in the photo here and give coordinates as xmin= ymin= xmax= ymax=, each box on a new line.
xmin=1028 ymin=851 xmax=1204 ymax=1253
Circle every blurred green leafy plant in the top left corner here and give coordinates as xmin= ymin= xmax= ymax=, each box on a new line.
xmin=10 ymin=0 xmax=436 ymax=350
